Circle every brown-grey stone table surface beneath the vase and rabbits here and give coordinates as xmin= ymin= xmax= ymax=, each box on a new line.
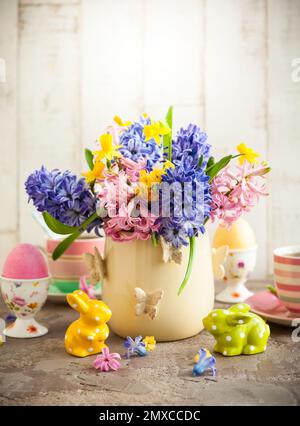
xmin=0 ymin=283 xmax=300 ymax=405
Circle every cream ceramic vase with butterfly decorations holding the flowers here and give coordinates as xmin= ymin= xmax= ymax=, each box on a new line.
xmin=102 ymin=233 xmax=214 ymax=341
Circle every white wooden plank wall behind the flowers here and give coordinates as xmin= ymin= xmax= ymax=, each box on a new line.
xmin=0 ymin=0 xmax=300 ymax=278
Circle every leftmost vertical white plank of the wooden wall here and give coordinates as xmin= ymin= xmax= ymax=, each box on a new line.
xmin=0 ymin=0 xmax=20 ymax=270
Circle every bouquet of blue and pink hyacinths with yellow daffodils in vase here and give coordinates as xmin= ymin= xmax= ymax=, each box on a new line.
xmin=25 ymin=107 xmax=270 ymax=294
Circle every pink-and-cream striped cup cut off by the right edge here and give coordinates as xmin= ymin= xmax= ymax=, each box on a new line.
xmin=273 ymin=245 xmax=300 ymax=316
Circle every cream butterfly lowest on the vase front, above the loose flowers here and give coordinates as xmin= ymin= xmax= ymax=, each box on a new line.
xmin=133 ymin=287 xmax=164 ymax=320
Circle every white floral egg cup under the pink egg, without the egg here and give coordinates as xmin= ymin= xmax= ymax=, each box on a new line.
xmin=1 ymin=277 xmax=51 ymax=339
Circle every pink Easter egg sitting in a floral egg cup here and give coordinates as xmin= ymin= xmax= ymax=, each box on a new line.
xmin=2 ymin=244 xmax=49 ymax=280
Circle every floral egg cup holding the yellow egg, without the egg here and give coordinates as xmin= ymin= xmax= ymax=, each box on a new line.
xmin=216 ymin=247 xmax=257 ymax=303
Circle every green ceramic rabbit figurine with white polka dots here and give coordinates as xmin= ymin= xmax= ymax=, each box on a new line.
xmin=203 ymin=303 xmax=270 ymax=356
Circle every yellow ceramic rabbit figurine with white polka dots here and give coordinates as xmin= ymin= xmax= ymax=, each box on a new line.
xmin=65 ymin=290 xmax=111 ymax=357
